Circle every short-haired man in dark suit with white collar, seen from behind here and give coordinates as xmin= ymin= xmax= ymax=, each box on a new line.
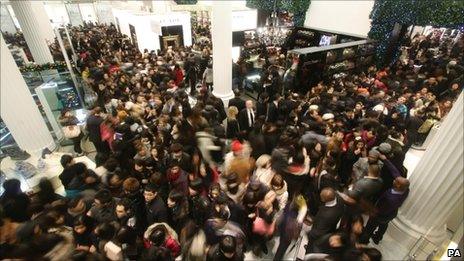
xmin=308 ymin=187 xmax=345 ymax=244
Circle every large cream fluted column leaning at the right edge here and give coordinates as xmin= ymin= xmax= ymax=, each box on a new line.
xmin=387 ymin=93 xmax=464 ymax=257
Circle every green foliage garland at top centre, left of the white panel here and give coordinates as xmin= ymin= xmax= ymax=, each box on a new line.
xmin=247 ymin=0 xmax=311 ymax=26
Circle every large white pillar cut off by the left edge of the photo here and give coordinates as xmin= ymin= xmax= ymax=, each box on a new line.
xmin=0 ymin=36 xmax=55 ymax=153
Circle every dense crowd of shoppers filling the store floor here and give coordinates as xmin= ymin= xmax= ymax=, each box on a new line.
xmin=0 ymin=21 xmax=463 ymax=261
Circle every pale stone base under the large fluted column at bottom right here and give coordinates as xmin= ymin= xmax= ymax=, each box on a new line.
xmin=378 ymin=215 xmax=447 ymax=260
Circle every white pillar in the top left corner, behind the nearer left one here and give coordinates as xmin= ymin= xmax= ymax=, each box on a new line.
xmin=10 ymin=1 xmax=55 ymax=64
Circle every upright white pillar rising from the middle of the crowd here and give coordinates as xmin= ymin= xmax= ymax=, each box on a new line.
xmin=211 ymin=1 xmax=234 ymax=104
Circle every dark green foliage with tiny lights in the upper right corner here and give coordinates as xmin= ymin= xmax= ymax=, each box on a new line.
xmin=368 ymin=0 xmax=464 ymax=65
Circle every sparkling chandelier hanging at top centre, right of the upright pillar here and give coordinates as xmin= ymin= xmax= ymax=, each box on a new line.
xmin=256 ymin=0 xmax=290 ymax=46
